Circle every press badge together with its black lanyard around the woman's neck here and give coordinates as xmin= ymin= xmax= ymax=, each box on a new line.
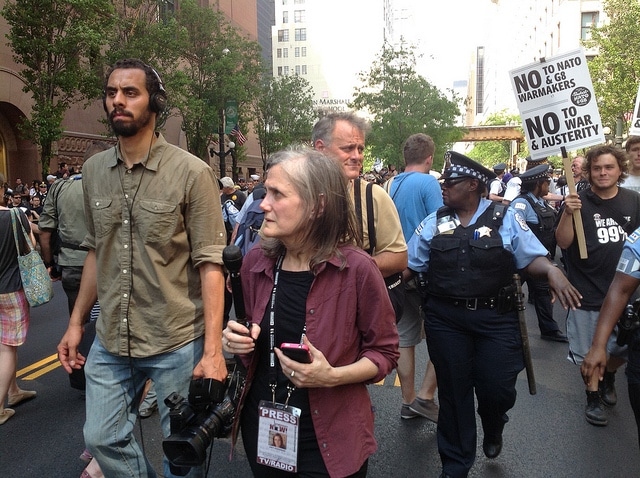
xmin=256 ymin=256 xmax=302 ymax=473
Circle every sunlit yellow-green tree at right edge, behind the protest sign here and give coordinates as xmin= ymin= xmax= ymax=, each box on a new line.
xmin=584 ymin=0 xmax=640 ymax=134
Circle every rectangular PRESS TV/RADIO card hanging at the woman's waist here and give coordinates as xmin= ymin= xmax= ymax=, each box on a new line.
xmin=256 ymin=400 xmax=301 ymax=473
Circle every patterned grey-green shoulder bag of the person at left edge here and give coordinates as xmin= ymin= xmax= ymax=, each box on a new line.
xmin=11 ymin=208 xmax=53 ymax=307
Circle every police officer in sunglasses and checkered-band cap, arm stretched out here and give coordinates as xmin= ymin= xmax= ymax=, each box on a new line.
xmin=408 ymin=151 xmax=580 ymax=478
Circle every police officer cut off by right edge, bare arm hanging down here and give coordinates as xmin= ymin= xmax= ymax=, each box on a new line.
xmin=580 ymin=228 xmax=640 ymax=450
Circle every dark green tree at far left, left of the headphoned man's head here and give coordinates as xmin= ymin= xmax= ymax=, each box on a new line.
xmin=2 ymin=0 xmax=114 ymax=177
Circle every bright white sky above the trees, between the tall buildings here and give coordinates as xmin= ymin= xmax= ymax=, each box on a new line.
xmin=308 ymin=0 xmax=495 ymax=95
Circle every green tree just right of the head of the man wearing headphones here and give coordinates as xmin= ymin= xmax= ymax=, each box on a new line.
xmin=169 ymin=0 xmax=262 ymax=168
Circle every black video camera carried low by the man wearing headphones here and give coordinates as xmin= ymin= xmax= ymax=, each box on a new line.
xmin=162 ymin=359 xmax=246 ymax=476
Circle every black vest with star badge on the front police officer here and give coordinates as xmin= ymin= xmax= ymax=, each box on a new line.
xmin=427 ymin=203 xmax=516 ymax=298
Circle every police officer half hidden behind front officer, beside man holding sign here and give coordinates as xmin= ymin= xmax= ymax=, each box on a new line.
xmin=510 ymin=164 xmax=568 ymax=342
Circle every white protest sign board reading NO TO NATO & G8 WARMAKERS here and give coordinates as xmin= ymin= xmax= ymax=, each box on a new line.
xmin=509 ymin=48 xmax=605 ymax=159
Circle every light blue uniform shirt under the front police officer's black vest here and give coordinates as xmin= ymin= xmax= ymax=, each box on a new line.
xmin=407 ymin=199 xmax=548 ymax=272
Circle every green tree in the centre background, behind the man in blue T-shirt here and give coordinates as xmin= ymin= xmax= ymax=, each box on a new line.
xmin=350 ymin=42 xmax=464 ymax=170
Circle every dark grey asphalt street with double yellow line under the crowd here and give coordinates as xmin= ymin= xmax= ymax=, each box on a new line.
xmin=0 ymin=282 xmax=640 ymax=478
